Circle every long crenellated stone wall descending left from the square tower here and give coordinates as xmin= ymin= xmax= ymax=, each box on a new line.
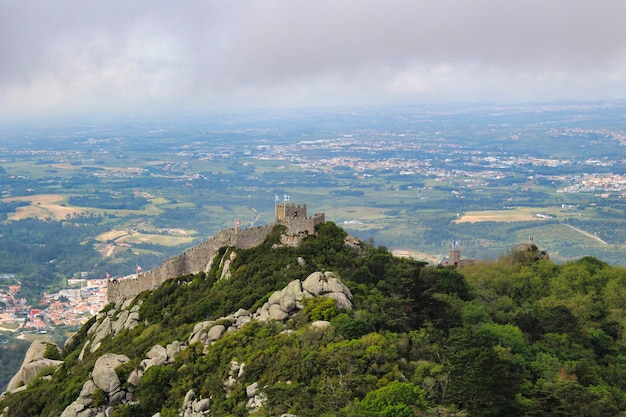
xmin=107 ymin=224 xmax=274 ymax=303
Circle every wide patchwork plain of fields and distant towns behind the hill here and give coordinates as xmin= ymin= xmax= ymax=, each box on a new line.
xmin=0 ymin=104 xmax=626 ymax=302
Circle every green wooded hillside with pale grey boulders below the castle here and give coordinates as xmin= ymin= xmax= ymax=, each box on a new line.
xmin=0 ymin=222 xmax=626 ymax=417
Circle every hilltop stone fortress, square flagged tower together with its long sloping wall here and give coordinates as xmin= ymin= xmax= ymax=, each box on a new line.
xmin=107 ymin=203 xmax=326 ymax=303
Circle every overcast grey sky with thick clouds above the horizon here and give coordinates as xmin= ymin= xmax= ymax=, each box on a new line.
xmin=0 ymin=0 xmax=626 ymax=117
